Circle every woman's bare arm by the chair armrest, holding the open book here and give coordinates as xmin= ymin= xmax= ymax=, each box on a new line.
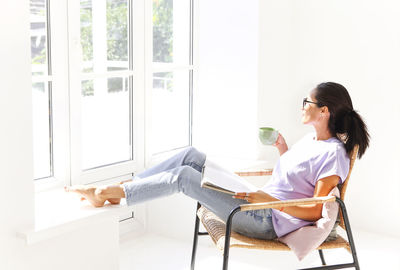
xmin=233 ymin=175 xmax=339 ymax=221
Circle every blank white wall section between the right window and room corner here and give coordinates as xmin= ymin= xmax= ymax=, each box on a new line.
xmin=193 ymin=0 xmax=258 ymax=158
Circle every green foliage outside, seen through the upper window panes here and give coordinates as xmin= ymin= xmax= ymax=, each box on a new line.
xmin=31 ymin=0 xmax=173 ymax=96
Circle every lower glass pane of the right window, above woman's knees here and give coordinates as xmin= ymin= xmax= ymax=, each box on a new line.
xmin=150 ymin=71 xmax=190 ymax=153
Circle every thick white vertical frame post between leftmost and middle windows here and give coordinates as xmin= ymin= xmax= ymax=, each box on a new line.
xmin=33 ymin=0 xmax=70 ymax=192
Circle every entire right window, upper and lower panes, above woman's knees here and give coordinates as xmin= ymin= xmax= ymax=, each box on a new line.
xmin=149 ymin=0 xmax=193 ymax=153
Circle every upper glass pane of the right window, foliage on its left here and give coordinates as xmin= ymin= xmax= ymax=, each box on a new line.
xmin=153 ymin=0 xmax=190 ymax=64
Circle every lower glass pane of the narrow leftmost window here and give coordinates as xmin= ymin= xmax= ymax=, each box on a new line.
xmin=32 ymin=82 xmax=51 ymax=179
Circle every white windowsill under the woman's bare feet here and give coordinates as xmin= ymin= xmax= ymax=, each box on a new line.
xmin=18 ymin=188 xmax=133 ymax=245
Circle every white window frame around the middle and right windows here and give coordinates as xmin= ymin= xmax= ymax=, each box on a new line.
xmin=35 ymin=0 xmax=197 ymax=191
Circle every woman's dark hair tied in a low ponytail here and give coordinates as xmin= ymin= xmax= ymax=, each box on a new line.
xmin=311 ymin=82 xmax=370 ymax=158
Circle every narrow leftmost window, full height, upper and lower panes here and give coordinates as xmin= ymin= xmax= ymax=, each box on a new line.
xmin=30 ymin=0 xmax=53 ymax=179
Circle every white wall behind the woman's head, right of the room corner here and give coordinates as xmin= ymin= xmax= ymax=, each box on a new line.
xmin=259 ymin=0 xmax=400 ymax=235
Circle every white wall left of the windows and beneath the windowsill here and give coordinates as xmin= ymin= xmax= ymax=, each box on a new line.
xmin=0 ymin=0 xmax=119 ymax=270
